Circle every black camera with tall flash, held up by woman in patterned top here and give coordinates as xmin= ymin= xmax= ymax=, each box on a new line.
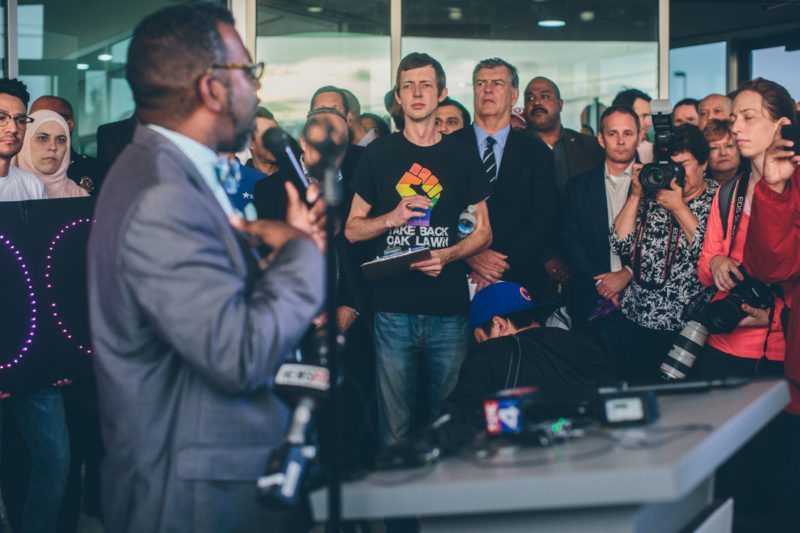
xmin=639 ymin=100 xmax=686 ymax=196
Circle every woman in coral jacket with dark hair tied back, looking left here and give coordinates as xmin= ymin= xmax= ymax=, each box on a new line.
xmin=696 ymin=79 xmax=795 ymax=377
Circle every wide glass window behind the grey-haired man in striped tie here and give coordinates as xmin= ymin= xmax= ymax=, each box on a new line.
xmin=402 ymin=0 xmax=658 ymax=130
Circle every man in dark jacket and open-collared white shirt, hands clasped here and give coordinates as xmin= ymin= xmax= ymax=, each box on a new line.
xmin=561 ymin=106 xmax=639 ymax=327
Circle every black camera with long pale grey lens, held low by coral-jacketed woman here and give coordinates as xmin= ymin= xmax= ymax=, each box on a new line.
xmin=660 ymin=266 xmax=775 ymax=380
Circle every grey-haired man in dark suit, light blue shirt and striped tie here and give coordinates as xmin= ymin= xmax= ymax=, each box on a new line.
xmin=450 ymin=59 xmax=561 ymax=295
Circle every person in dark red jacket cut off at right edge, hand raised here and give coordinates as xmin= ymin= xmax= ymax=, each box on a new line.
xmin=745 ymin=82 xmax=800 ymax=531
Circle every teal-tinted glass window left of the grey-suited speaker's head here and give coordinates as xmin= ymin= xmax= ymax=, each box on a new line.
xmin=18 ymin=0 xmax=225 ymax=154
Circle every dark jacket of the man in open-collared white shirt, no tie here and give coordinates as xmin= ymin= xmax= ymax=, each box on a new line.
xmin=561 ymin=166 xmax=611 ymax=320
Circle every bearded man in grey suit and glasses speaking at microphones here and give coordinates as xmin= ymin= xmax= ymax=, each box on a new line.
xmin=89 ymin=4 xmax=324 ymax=533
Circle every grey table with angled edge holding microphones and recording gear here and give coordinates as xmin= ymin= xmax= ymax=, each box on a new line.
xmin=311 ymin=380 xmax=789 ymax=533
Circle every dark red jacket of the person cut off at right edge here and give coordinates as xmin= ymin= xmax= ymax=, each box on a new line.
xmin=744 ymin=168 xmax=800 ymax=414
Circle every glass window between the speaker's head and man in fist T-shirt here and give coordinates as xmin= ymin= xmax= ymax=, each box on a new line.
xmin=256 ymin=0 xmax=391 ymax=135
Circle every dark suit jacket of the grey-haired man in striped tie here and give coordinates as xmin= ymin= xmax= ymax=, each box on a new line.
xmin=451 ymin=126 xmax=558 ymax=296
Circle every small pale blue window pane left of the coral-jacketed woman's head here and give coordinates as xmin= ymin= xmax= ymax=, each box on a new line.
xmin=669 ymin=42 xmax=727 ymax=104
